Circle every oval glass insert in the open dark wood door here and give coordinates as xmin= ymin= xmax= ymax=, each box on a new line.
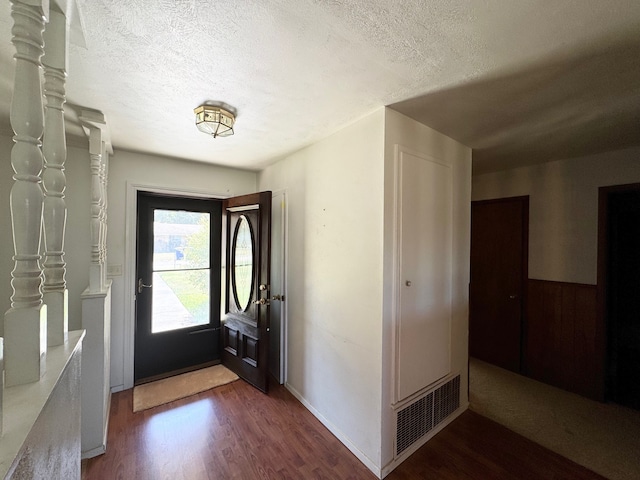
xmin=232 ymin=215 xmax=254 ymax=312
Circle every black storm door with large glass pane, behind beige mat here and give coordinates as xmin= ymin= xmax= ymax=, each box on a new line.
xmin=134 ymin=192 xmax=222 ymax=381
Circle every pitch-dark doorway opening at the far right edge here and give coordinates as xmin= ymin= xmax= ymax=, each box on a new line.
xmin=607 ymin=189 xmax=640 ymax=409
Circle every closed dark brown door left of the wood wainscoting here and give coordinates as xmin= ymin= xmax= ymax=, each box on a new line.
xmin=469 ymin=197 xmax=529 ymax=373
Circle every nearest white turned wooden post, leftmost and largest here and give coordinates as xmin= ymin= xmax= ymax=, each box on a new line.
xmin=4 ymin=0 xmax=49 ymax=386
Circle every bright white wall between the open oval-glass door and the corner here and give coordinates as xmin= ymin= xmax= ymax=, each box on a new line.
xmin=258 ymin=109 xmax=384 ymax=471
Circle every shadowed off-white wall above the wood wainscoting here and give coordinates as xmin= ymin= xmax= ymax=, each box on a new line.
xmin=473 ymin=148 xmax=640 ymax=285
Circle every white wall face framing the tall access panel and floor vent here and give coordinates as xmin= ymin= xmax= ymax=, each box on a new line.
xmin=381 ymin=109 xmax=471 ymax=472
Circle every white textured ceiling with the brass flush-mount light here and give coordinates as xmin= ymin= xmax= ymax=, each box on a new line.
xmin=0 ymin=0 xmax=640 ymax=172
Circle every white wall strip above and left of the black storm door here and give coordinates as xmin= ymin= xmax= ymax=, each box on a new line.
xmin=107 ymin=150 xmax=256 ymax=390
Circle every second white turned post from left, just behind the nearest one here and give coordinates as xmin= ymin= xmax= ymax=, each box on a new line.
xmin=42 ymin=10 xmax=69 ymax=346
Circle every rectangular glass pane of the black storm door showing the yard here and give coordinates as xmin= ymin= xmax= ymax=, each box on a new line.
xmin=151 ymin=209 xmax=211 ymax=333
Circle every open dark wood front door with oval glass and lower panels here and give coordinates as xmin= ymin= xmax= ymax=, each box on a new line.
xmin=222 ymin=192 xmax=271 ymax=392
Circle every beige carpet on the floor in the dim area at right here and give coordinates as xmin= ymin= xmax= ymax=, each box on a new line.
xmin=469 ymin=358 xmax=640 ymax=480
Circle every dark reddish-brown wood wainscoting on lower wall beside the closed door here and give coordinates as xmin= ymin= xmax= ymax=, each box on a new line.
xmin=524 ymin=279 xmax=604 ymax=401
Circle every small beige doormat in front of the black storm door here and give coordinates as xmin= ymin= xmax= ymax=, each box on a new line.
xmin=133 ymin=365 xmax=238 ymax=412
